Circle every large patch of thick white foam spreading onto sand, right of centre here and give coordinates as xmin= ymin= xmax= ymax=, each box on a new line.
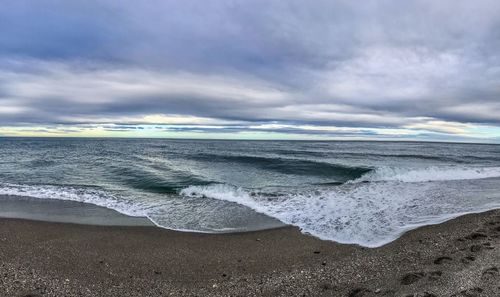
xmin=181 ymin=182 xmax=500 ymax=247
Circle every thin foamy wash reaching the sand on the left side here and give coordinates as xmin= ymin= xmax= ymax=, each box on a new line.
xmin=0 ymin=183 xmax=283 ymax=233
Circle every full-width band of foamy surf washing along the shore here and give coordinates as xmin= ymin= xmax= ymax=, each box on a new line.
xmin=0 ymin=179 xmax=500 ymax=247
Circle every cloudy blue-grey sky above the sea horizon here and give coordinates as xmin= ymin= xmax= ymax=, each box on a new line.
xmin=0 ymin=0 xmax=500 ymax=143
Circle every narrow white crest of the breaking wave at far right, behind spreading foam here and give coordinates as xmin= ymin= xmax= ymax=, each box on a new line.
xmin=353 ymin=166 xmax=500 ymax=182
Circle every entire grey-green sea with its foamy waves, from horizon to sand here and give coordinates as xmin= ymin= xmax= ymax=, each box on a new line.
xmin=0 ymin=138 xmax=500 ymax=247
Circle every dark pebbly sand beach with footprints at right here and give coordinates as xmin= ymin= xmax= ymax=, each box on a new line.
xmin=0 ymin=210 xmax=500 ymax=297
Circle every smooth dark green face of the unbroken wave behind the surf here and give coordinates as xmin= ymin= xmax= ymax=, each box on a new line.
xmin=193 ymin=154 xmax=372 ymax=182
